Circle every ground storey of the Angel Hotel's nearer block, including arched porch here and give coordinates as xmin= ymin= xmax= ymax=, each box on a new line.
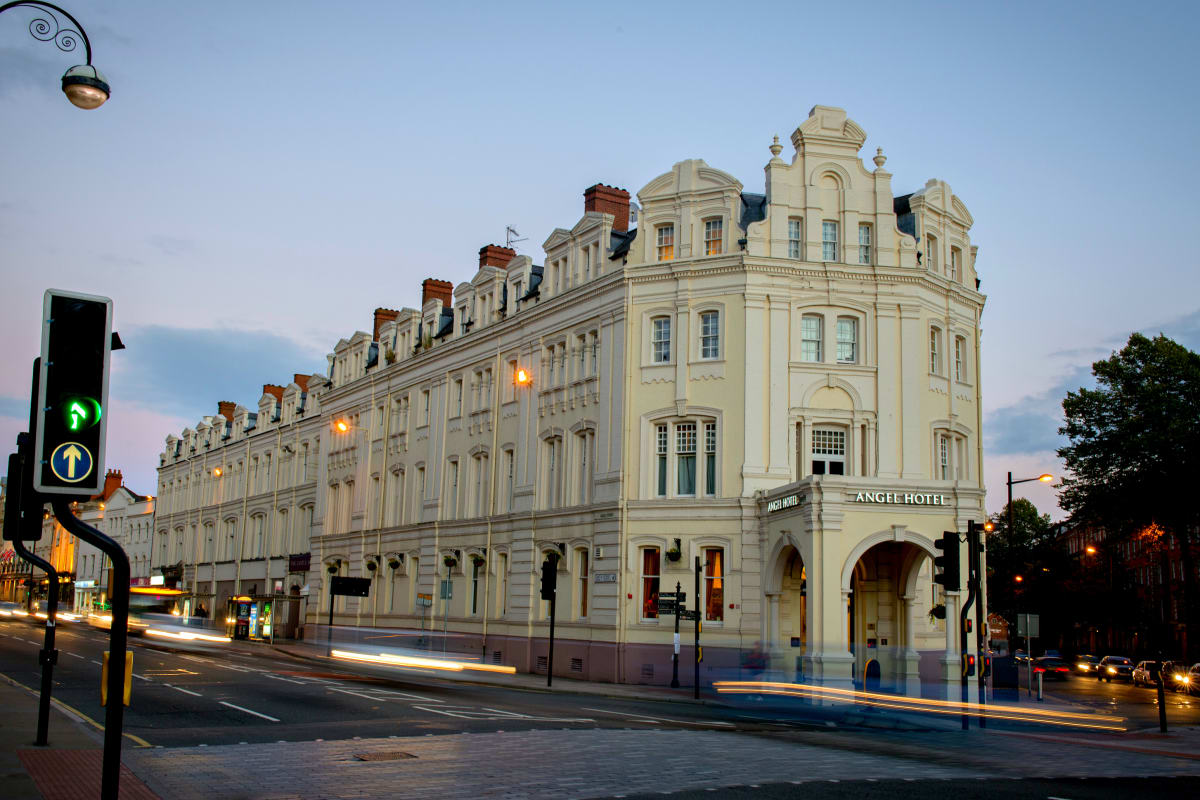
xmin=302 ymin=476 xmax=986 ymax=696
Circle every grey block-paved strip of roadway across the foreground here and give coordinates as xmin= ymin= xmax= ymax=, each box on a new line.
xmin=125 ymin=729 xmax=1200 ymax=800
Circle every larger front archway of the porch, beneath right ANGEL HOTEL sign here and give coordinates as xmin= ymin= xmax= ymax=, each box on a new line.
xmin=846 ymin=540 xmax=944 ymax=694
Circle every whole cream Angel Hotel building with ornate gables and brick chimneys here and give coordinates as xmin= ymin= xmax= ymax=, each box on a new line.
xmin=156 ymin=106 xmax=984 ymax=692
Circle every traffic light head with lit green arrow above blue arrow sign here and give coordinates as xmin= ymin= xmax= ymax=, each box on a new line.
xmin=34 ymin=289 xmax=113 ymax=495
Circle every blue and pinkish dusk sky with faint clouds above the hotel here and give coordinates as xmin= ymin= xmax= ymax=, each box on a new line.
xmin=0 ymin=0 xmax=1200 ymax=519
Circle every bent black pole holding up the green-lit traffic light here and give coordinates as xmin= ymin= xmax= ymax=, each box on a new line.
xmin=54 ymin=497 xmax=130 ymax=800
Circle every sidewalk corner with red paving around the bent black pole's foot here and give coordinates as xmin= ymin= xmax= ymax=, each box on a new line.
xmin=0 ymin=675 xmax=158 ymax=800
